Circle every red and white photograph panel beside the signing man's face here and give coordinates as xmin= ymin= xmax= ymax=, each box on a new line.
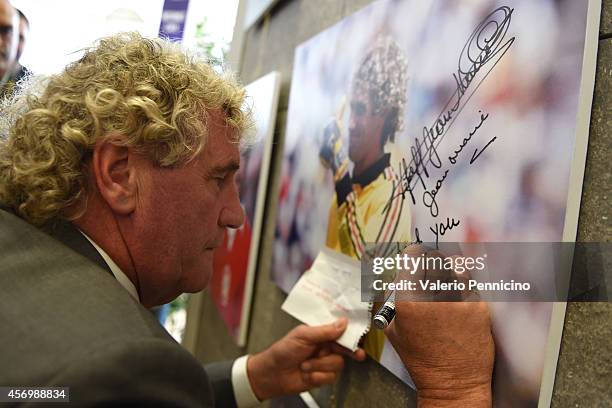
xmin=210 ymin=72 xmax=280 ymax=346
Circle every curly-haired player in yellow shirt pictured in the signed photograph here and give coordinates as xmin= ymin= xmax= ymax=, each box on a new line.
xmin=319 ymin=37 xmax=411 ymax=361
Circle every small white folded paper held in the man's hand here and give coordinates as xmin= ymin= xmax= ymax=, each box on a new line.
xmin=282 ymin=249 xmax=372 ymax=351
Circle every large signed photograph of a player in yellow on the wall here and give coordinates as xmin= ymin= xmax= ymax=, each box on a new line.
xmin=272 ymin=0 xmax=598 ymax=407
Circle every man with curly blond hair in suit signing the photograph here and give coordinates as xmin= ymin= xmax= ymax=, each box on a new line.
xmin=0 ymin=34 xmax=365 ymax=407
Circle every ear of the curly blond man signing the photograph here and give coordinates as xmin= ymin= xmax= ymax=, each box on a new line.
xmin=92 ymin=139 xmax=138 ymax=215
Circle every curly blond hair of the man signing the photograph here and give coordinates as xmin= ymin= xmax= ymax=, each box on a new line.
xmin=0 ymin=33 xmax=252 ymax=225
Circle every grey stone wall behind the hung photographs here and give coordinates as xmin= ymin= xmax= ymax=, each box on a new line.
xmin=196 ymin=0 xmax=612 ymax=407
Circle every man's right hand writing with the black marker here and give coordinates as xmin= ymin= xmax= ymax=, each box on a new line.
xmin=385 ymin=244 xmax=495 ymax=407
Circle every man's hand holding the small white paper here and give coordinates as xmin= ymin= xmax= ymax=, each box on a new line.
xmin=247 ymin=319 xmax=365 ymax=401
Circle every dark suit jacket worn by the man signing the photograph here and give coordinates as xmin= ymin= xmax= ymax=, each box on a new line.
xmin=0 ymin=210 xmax=235 ymax=407
